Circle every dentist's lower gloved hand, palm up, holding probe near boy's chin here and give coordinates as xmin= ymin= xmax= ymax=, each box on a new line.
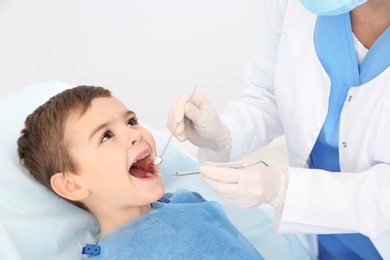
xmin=199 ymin=162 xmax=288 ymax=213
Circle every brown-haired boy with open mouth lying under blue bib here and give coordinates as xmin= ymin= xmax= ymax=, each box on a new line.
xmin=18 ymin=86 xmax=262 ymax=259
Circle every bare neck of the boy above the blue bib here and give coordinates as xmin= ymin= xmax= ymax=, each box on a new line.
xmin=93 ymin=204 xmax=152 ymax=238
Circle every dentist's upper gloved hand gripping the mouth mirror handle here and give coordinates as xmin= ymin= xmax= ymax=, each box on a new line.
xmin=167 ymin=93 xmax=231 ymax=152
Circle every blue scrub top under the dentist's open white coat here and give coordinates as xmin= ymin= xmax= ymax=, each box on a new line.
xmin=308 ymin=13 xmax=390 ymax=259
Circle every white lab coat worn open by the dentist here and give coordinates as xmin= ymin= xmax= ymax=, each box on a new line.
xmin=199 ymin=0 xmax=390 ymax=259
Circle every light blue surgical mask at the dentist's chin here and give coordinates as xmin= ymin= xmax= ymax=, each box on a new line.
xmin=299 ymin=0 xmax=367 ymax=15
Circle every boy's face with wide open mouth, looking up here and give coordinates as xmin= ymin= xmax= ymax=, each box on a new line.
xmin=65 ymin=97 xmax=164 ymax=211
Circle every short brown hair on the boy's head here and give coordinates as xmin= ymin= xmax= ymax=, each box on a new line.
xmin=18 ymin=86 xmax=111 ymax=209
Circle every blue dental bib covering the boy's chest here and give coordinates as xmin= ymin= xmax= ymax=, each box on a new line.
xmin=87 ymin=189 xmax=263 ymax=259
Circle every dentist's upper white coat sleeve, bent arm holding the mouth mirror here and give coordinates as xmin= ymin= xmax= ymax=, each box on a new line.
xmin=198 ymin=0 xmax=287 ymax=162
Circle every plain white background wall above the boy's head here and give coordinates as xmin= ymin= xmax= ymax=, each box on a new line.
xmin=0 ymin=0 xmax=286 ymax=165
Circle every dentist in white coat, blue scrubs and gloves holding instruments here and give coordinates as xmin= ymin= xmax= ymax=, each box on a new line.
xmin=168 ymin=0 xmax=390 ymax=259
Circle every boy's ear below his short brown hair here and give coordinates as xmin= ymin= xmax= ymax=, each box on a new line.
xmin=50 ymin=172 xmax=89 ymax=201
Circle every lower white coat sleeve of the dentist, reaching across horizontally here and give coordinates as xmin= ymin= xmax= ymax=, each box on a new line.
xmin=277 ymin=164 xmax=390 ymax=237
